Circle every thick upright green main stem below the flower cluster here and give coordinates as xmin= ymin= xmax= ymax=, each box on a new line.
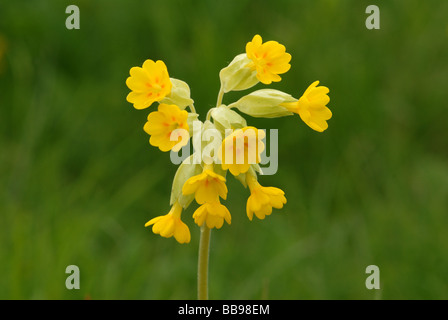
xmin=198 ymin=224 xmax=211 ymax=300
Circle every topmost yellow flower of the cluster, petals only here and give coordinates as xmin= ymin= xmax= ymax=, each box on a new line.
xmin=246 ymin=34 xmax=291 ymax=84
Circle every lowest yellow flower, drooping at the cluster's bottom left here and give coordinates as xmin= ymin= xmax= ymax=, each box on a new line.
xmin=145 ymin=202 xmax=191 ymax=243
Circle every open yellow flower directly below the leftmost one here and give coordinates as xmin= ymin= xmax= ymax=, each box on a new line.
xmin=143 ymin=103 xmax=189 ymax=152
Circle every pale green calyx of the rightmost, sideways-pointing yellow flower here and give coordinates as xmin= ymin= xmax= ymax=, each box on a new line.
xmin=229 ymin=89 xmax=297 ymax=118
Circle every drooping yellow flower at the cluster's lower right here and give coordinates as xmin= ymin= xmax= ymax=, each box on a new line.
xmin=246 ymin=174 xmax=286 ymax=221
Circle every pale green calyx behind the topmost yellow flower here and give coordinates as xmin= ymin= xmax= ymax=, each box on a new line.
xmin=219 ymin=53 xmax=259 ymax=93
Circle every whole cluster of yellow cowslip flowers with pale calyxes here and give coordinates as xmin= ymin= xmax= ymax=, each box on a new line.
xmin=126 ymin=35 xmax=332 ymax=243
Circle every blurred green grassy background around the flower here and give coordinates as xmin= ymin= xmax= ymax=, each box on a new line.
xmin=0 ymin=0 xmax=448 ymax=299
